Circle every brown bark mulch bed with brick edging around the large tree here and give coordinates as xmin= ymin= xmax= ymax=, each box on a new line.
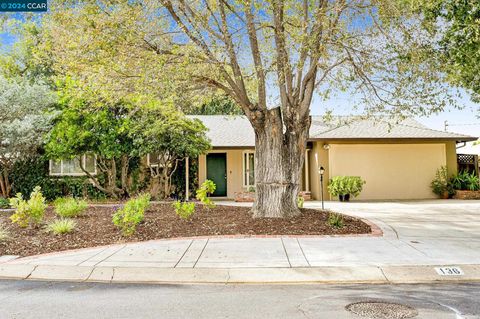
xmin=0 ymin=204 xmax=371 ymax=256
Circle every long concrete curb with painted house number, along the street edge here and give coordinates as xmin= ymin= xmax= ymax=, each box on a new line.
xmin=0 ymin=264 xmax=480 ymax=284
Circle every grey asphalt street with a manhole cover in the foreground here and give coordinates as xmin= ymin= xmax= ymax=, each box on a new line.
xmin=0 ymin=281 xmax=480 ymax=319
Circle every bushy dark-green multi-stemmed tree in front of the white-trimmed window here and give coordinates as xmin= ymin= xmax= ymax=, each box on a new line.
xmin=46 ymin=86 xmax=137 ymax=198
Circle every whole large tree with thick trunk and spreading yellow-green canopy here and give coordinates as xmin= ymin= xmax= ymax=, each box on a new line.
xmin=15 ymin=0 xmax=468 ymax=217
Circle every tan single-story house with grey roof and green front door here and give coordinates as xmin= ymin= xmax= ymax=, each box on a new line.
xmin=191 ymin=115 xmax=476 ymax=200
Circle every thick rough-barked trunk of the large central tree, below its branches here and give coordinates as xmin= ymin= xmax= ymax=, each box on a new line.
xmin=252 ymin=109 xmax=310 ymax=217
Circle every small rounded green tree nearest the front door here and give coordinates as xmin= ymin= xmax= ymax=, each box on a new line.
xmin=132 ymin=107 xmax=210 ymax=198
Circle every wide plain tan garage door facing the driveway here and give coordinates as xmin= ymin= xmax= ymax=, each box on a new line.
xmin=329 ymin=143 xmax=446 ymax=200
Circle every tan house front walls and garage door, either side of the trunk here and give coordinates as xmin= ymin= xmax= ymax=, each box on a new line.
xmin=199 ymin=141 xmax=457 ymax=200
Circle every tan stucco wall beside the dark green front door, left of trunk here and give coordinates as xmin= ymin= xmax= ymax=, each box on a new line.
xmin=198 ymin=149 xmax=251 ymax=199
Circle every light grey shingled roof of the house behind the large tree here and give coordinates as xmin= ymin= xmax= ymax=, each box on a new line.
xmin=188 ymin=115 xmax=476 ymax=147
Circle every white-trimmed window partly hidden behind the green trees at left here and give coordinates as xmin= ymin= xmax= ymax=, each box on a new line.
xmin=49 ymin=155 xmax=97 ymax=176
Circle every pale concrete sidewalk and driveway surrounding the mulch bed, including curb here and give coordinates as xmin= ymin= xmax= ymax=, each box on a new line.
xmin=0 ymin=201 xmax=480 ymax=283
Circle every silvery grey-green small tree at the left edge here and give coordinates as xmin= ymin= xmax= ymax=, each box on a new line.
xmin=0 ymin=76 xmax=55 ymax=197
